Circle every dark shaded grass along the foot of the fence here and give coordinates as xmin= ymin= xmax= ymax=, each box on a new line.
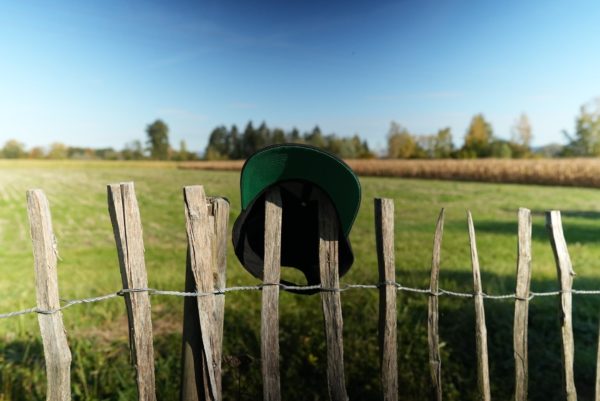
xmin=0 ymin=270 xmax=600 ymax=401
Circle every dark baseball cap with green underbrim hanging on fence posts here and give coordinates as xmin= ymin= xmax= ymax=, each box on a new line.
xmin=233 ymin=144 xmax=360 ymax=285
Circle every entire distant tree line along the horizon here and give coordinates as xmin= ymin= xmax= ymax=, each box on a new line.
xmin=0 ymin=98 xmax=600 ymax=161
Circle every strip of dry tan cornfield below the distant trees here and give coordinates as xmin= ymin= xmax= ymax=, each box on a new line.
xmin=179 ymin=159 xmax=600 ymax=187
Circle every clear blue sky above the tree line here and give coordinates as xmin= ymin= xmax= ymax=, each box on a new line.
xmin=0 ymin=0 xmax=600 ymax=150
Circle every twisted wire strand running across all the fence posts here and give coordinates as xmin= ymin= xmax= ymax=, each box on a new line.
xmin=0 ymin=281 xmax=600 ymax=319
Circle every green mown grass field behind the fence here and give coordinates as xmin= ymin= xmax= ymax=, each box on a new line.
xmin=0 ymin=161 xmax=600 ymax=400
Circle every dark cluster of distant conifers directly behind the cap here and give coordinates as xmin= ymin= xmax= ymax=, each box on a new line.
xmin=204 ymin=121 xmax=375 ymax=160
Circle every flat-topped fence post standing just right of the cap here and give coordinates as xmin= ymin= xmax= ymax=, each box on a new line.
xmin=375 ymin=198 xmax=398 ymax=401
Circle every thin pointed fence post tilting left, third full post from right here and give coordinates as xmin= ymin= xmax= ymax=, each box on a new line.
xmin=467 ymin=211 xmax=491 ymax=401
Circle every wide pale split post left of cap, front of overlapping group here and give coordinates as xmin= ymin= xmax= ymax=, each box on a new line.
xmin=183 ymin=185 xmax=220 ymax=400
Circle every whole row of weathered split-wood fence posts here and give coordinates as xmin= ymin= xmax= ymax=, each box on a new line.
xmin=19 ymin=183 xmax=600 ymax=401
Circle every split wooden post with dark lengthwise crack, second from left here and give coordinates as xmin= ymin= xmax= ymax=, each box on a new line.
xmin=107 ymin=182 xmax=156 ymax=401
